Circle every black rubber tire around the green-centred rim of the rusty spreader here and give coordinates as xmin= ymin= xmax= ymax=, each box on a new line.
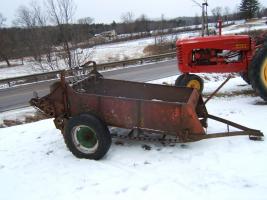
xmin=63 ymin=114 xmax=111 ymax=160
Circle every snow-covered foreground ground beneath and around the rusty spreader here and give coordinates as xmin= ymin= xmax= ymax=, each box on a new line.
xmin=0 ymin=74 xmax=267 ymax=200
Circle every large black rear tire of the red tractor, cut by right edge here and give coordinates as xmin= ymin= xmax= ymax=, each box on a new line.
xmin=248 ymin=45 xmax=267 ymax=101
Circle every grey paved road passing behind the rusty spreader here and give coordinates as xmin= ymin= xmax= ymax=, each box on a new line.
xmin=0 ymin=60 xmax=178 ymax=112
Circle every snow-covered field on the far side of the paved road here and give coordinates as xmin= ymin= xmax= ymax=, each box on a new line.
xmin=0 ymin=18 xmax=267 ymax=79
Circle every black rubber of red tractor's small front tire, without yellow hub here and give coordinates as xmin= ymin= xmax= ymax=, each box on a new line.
xmin=175 ymin=74 xmax=204 ymax=93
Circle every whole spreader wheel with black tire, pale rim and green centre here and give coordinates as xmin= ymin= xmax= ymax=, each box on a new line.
xmin=64 ymin=114 xmax=111 ymax=160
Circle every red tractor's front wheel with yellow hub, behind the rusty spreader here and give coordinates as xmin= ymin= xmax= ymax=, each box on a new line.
xmin=175 ymin=74 xmax=204 ymax=93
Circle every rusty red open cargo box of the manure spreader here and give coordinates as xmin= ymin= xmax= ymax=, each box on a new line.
xmin=71 ymin=78 xmax=209 ymax=135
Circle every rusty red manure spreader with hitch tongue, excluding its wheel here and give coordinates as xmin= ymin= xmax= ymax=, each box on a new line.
xmin=30 ymin=68 xmax=263 ymax=142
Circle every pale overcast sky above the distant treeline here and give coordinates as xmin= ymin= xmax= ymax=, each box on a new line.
xmin=0 ymin=0 xmax=267 ymax=25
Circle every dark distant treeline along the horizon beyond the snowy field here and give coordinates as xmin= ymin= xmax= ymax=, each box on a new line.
xmin=0 ymin=12 xmax=251 ymax=61
